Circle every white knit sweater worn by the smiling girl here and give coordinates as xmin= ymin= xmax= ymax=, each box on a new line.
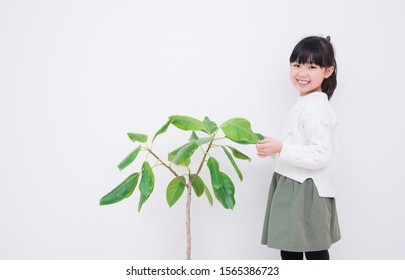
xmin=274 ymin=92 xmax=338 ymax=197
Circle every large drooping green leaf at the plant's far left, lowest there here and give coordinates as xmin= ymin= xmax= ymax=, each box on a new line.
xmin=100 ymin=172 xmax=139 ymax=205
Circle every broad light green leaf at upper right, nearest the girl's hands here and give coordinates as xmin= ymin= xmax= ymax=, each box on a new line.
xmin=221 ymin=118 xmax=259 ymax=144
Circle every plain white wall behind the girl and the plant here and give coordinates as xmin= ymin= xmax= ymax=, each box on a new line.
xmin=0 ymin=0 xmax=405 ymax=259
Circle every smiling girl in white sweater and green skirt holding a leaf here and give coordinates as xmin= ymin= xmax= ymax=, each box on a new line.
xmin=256 ymin=36 xmax=340 ymax=260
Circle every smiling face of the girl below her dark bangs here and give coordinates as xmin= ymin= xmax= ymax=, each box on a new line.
xmin=290 ymin=62 xmax=334 ymax=96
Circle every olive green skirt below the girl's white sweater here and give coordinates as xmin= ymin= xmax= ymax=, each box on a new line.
xmin=262 ymin=173 xmax=340 ymax=252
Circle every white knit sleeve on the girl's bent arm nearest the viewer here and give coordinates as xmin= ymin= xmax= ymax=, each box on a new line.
xmin=279 ymin=107 xmax=333 ymax=169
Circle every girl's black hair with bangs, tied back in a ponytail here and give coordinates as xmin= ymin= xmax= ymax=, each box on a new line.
xmin=290 ymin=36 xmax=337 ymax=99
